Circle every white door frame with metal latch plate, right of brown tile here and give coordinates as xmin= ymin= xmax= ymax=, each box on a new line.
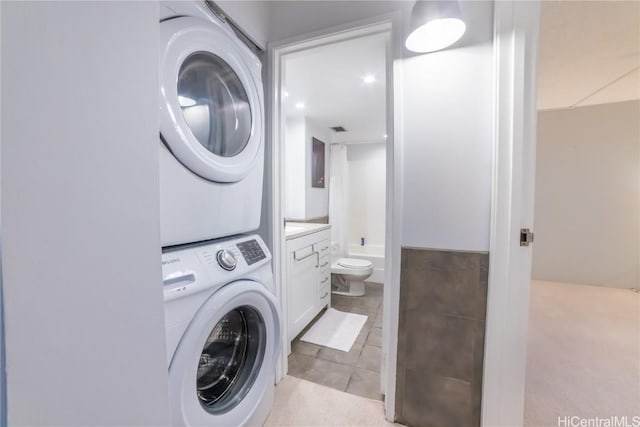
xmin=481 ymin=0 xmax=540 ymax=426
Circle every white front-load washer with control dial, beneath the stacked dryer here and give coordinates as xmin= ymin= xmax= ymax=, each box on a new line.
xmin=162 ymin=235 xmax=280 ymax=427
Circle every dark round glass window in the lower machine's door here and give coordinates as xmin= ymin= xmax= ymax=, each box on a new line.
xmin=196 ymin=306 xmax=266 ymax=414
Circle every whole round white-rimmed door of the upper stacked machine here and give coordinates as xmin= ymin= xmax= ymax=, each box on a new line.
xmin=160 ymin=17 xmax=264 ymax=182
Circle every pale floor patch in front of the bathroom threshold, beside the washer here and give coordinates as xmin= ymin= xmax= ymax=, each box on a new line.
xmin=265 ymin=376 xmax=400 ymax=427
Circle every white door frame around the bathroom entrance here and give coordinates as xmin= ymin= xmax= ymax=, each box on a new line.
xmin=266 ymin=11 xmax=402 ymax=420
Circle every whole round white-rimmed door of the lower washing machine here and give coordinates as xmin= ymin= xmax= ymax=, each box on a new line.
xmin=169 ymin=281 xmax=280 ymax=426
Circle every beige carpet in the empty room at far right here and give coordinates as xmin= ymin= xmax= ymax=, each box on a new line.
xmin=525 ymin=281 xmax=640 ymax=427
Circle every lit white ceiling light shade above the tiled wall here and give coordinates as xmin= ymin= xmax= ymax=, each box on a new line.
xmin=405 ymin=0 xmax=466 ymax=53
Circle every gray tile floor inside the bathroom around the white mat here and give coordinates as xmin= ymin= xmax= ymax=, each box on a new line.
xmin=289 ymin=283 xmax=382 ymax=400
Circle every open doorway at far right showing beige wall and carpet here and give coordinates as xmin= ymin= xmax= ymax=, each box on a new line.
xmin=524 ymin=2 xmax=640 ymax=426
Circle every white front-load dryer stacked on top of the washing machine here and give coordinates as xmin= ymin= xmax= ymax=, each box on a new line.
xmin=160 ymin=1 xmax=264 ymax=247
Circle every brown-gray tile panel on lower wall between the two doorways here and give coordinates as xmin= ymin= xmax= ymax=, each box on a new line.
xmin=396 ymin=248 xmax=489 ymax=427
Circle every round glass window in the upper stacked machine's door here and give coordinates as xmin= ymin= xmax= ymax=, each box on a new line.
xmin=177 ymin=52 xmax=251 ymax=157
